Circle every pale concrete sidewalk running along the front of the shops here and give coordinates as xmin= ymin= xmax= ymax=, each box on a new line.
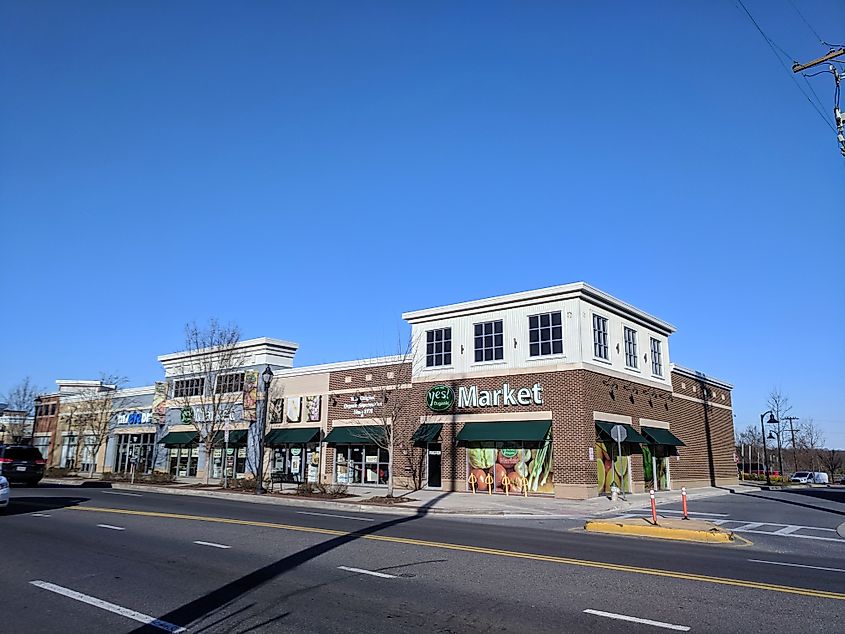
xmin=36 ymin=478 xmax=730 ymax=518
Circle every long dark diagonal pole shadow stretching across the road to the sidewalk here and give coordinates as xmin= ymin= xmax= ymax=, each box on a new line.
xmin=132 ymin=492 xmax=449 ymax=634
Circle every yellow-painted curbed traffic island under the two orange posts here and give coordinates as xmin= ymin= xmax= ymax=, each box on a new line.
xmin=584 ymin=516 xmax=734 ymax=544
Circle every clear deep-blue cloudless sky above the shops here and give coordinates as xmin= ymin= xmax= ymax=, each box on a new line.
xmin=0 ymin=0 xmax=845 ymax=448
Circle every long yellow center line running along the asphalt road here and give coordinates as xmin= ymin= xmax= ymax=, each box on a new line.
xmin=68 ymin=506 xmax=845 ymax=601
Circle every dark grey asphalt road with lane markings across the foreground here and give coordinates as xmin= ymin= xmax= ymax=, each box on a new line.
xmin=0 ymin=487 xmax=845 ymax=632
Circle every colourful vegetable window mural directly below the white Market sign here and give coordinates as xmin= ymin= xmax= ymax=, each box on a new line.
xmin=467 ymin=437 xmax=555 ymax=495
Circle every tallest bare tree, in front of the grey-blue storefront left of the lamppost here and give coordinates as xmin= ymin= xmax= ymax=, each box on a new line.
xmin=174 ymin=319 xmax=248 ymax=484
